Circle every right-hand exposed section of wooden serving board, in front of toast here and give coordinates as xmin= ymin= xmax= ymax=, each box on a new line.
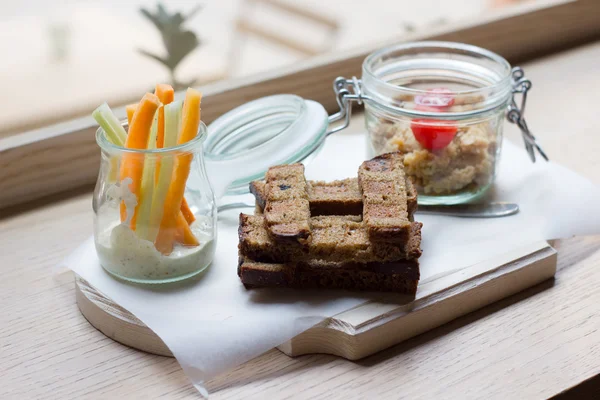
xmin=279 ymin=243 xmax=556 ymax=360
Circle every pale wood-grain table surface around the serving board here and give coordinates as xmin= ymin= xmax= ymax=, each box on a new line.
xmin=0 ymin=43 xmax=600 ymax=399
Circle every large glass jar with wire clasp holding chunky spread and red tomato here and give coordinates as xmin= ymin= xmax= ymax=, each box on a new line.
xmin=334 ymin=42 xmax=547 ymax=204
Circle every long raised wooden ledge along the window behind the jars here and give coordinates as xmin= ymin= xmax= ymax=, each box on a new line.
xmin=0 ymin=0 xmax=600 ymax=208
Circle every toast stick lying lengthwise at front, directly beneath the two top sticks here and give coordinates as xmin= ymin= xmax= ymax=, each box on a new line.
xmin=238 ymin=214 xmax=422 ymax=263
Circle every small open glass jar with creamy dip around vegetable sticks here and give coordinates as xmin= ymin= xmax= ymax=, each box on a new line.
xmin=93 ymin=124 xmax=217 ymax=283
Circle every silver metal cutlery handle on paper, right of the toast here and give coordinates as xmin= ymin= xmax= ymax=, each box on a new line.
xmin=417 ymin=203 xmax=519 ymax=218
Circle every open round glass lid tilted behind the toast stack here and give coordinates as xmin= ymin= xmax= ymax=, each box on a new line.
xmin=204 ymin=94 xmax=328 ymax=199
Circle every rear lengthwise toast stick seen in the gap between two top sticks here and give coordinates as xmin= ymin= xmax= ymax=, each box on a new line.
xmin=250 ymin=177 xmax=417 ymax=219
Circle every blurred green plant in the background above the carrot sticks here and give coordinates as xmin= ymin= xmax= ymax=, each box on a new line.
xmin=138 ymin=3 xmax=202 ymax=90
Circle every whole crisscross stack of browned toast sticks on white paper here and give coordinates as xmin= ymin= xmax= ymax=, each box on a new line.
xmin=238 ymin=153 xmax=422 ymax=295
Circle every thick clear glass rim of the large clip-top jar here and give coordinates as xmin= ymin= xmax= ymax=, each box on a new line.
xmin=362 ymin=41 xmax=512 ymax=119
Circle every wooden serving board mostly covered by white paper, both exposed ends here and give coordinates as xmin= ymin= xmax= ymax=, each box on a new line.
xmin=75 ymin=242 xmax=557 ymax=360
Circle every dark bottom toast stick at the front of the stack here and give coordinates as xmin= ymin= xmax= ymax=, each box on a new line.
xmin=238 ymin=256 xmax=420 ymax=296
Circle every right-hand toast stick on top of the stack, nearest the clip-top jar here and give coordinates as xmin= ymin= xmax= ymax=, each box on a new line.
xmin=358 ymin=153 xmax=412 ymax=243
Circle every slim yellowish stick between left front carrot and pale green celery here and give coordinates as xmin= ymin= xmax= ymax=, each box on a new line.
xmin=135 ymin=112 xmax=158 ymax=241
